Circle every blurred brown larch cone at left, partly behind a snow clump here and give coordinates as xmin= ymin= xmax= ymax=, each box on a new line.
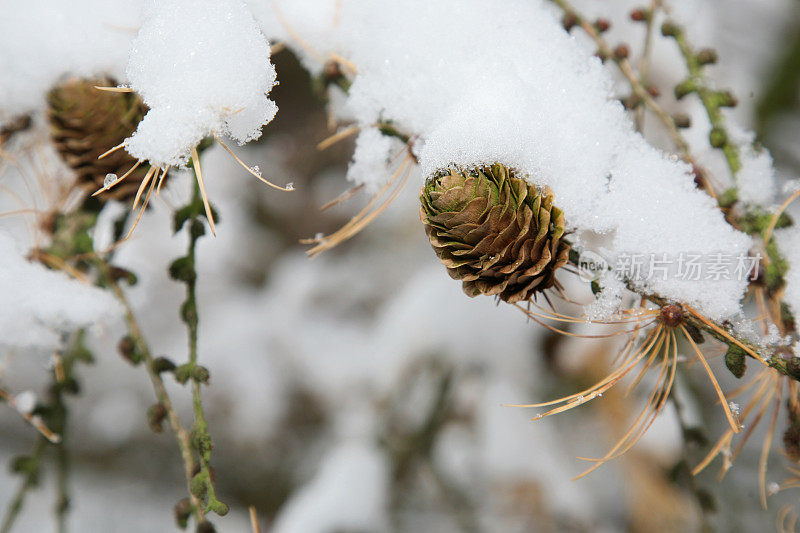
xmin=48 ymin=79 xmax=147 ymax=201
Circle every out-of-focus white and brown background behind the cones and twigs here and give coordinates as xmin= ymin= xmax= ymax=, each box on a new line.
xmin=0 ymin=0 xmax=800 ymax=533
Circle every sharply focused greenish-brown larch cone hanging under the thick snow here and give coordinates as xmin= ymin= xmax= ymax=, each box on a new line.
xmin=420 ymin=164 xmax=569 ymax=303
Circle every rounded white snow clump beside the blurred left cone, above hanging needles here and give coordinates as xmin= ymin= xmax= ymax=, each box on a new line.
xmin=126 ymin=0 xmax=278 ymax=167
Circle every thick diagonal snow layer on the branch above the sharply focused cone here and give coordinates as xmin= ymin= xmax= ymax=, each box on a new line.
xmin=264 ymin=0 xmax=751 ymax=319
